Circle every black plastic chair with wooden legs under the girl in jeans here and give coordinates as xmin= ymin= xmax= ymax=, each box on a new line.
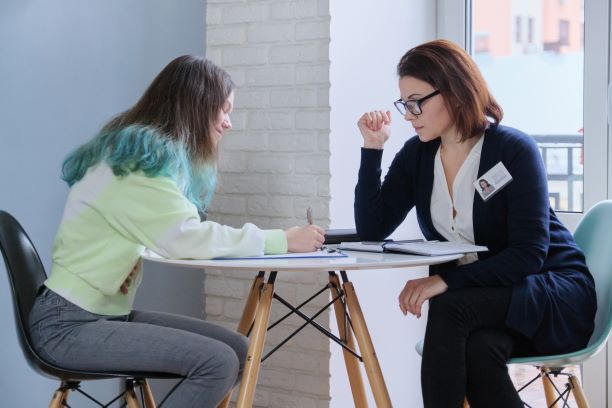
xmin=0 ymin=211 xmax=181 ymax=408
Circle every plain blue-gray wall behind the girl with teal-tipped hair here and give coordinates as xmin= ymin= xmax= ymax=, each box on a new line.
xmin=0 ymin=0 xmax=205 ymax=407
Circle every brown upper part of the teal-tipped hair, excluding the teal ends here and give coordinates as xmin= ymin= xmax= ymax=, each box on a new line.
xmin=101 ymin=55 xmax=234 ymax=166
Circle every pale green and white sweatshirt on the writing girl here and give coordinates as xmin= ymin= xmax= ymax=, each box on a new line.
xmin=45 ymin=163 xmax=287 ymax=315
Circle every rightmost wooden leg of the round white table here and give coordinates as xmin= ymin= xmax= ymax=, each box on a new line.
xmin=342 ymin=281 xmax=392 ymax=408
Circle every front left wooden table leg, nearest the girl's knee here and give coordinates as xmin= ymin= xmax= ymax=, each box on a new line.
xmin=236 ymin=272 xmax=276 ymax=408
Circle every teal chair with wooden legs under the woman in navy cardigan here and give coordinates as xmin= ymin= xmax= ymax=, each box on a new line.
xmin=415 ymin=201 xmax=612 ymax=408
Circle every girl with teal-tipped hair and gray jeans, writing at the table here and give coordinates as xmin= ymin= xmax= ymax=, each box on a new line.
xmin=30 ymin=56 xmax=323 ymax=408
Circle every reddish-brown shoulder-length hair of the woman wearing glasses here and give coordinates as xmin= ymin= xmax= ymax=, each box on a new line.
xmin=397 ymin=40 xmax=504 ymax=140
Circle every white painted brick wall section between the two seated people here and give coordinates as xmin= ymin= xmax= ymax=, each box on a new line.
xmin=205 ymin=0 xmax=330 ymax=408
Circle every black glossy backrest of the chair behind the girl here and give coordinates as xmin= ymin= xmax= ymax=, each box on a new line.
xmin=0 ymin=211 xmax=47 ymax=372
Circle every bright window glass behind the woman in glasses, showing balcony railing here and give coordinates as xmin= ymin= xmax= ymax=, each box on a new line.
xmin=472 ymin=0 xmax=584 ymax=212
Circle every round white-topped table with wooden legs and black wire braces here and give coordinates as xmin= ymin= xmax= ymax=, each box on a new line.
xmin=143 ymin=251 xmax=463 ymax=408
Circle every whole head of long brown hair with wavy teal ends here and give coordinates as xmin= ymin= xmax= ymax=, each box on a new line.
xmin=62 ymin=55 xmax=234 ymax=210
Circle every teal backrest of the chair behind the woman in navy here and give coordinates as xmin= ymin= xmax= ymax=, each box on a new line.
xmin=574 ymin=201 xmax=612 ymax=347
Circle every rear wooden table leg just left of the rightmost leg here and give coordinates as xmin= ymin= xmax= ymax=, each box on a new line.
xmin=329 ymin=272 xmax=368 ymax=408
